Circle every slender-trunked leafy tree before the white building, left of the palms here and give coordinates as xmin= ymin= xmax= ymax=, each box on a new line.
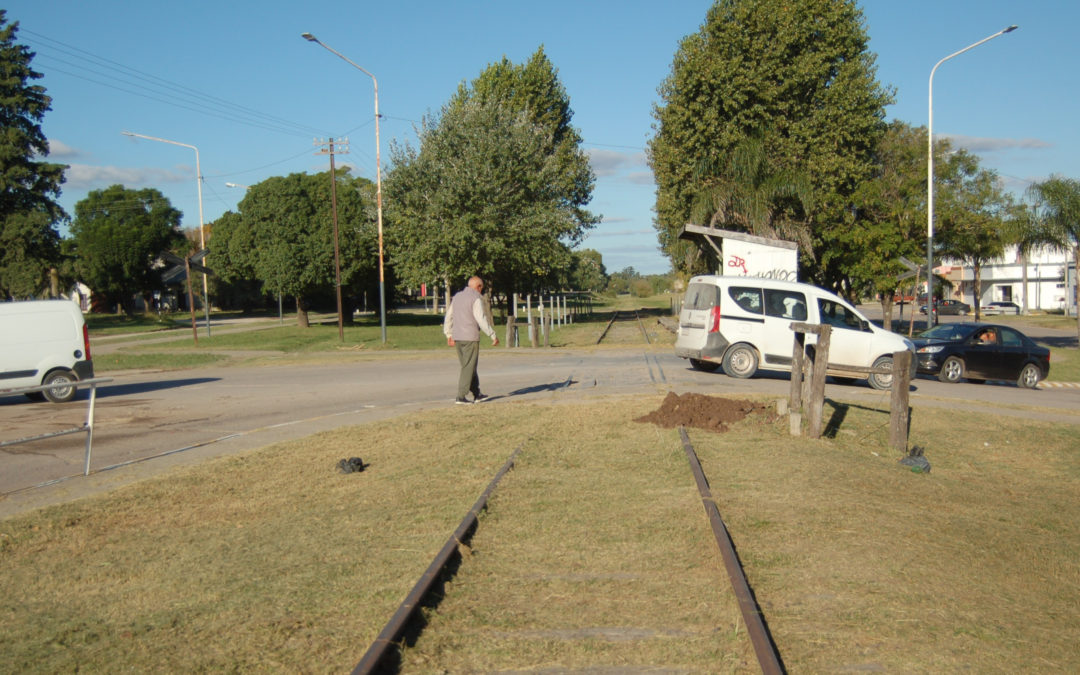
xmin=934 ymin=149 xmax=1011 ymax=321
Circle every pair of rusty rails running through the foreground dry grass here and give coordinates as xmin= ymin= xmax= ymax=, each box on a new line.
xmin=352 ymin=428 xmax=785 ymax=675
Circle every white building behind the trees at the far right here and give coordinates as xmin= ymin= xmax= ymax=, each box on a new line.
xmin=934 ymin=246 xmax=1076 ymax=312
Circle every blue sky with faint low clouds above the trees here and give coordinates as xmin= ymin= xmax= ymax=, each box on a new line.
xmin=5 ymin=0 xmax=1080 ymax=274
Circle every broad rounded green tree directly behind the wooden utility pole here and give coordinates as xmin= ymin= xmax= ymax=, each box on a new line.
xmin=210 ymin=168 xmax=378 ymax=327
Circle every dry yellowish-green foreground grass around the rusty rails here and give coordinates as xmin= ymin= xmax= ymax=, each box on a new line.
xmin=0 ymin=396 xmax=1080 ymax=673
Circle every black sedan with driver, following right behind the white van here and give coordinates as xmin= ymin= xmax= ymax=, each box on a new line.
xmin=913 ymin=323 xmax=1050 ymax=389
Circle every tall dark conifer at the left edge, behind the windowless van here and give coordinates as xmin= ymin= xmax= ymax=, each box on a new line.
xmin=0 ymin=10 xmax=67 ymax=299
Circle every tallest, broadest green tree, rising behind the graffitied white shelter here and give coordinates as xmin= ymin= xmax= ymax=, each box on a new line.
xmin=649 ymin=0 xmax=892 ymax=286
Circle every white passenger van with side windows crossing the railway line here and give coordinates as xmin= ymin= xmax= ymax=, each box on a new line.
xmin=675 ymin=274 xmax=917 ymax=389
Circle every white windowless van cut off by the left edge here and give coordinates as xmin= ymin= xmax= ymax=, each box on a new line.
xmin=0 ymin=300 xmax=94 ymax=403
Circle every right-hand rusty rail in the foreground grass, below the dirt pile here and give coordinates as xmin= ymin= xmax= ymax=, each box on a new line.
xmin=678 ymin=427 xmax=784 ymax=675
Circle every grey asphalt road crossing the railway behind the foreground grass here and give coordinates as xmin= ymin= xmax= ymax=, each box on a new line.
xmin=0 ymin=332 xmax=1080 ymax=517
